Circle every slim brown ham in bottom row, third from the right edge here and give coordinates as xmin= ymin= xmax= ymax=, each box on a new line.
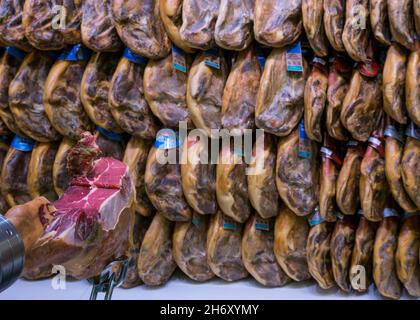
xmin=349 ymin=211 xmax=378 ymax=292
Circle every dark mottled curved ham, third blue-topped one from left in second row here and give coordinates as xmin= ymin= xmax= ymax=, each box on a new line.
xmin=108 ymin=52 xmax=159 ymax=140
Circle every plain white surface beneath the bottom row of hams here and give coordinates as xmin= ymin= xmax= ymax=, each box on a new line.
xmin=0 ymin=273 xmax=413 ymax=300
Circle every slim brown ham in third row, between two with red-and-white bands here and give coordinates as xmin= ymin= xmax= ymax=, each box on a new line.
xmin=336 ymin=140 xmax=365 ymax=215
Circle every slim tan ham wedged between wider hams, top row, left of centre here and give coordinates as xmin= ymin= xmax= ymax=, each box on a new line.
xmin=159 ymin=0 xmax=194 ymax=53
